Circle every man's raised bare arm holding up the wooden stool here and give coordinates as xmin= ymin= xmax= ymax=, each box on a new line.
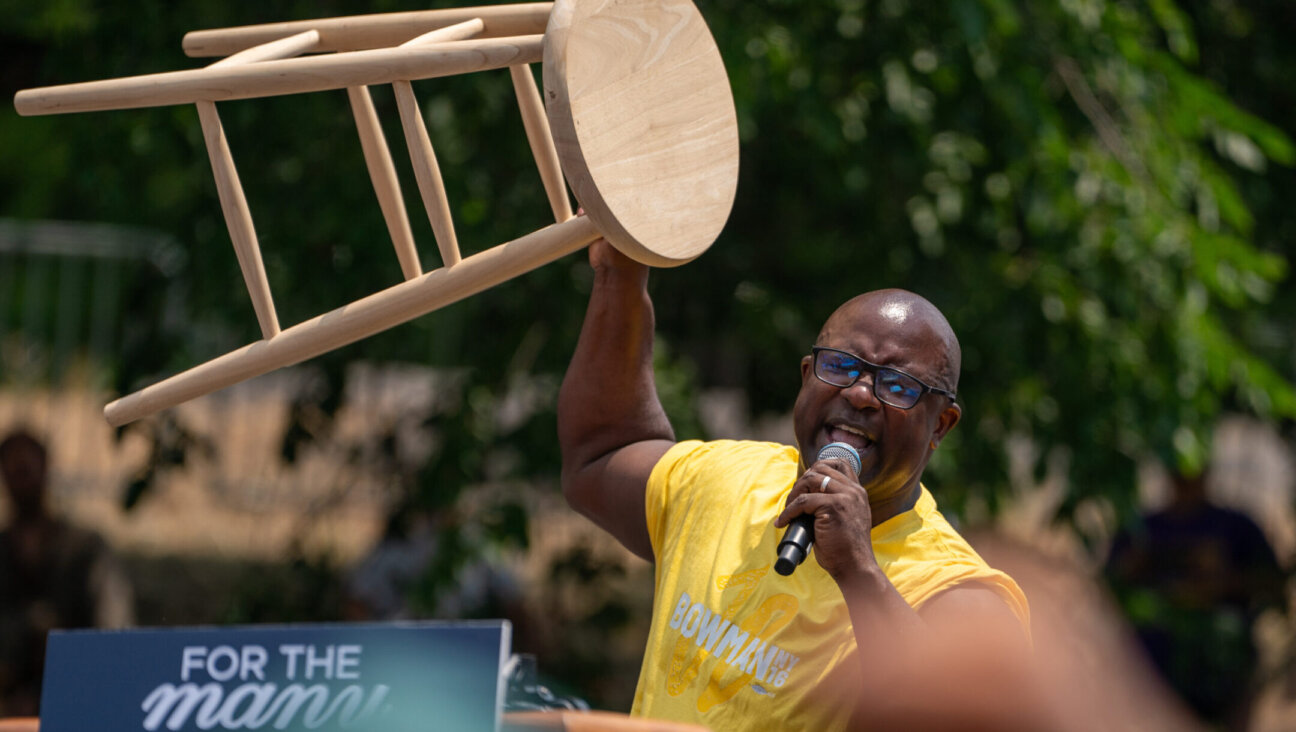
xmin=559 ymin=234 xmax=675 ymax=561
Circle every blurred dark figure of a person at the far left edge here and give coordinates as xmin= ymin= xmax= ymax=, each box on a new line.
xmin=0 ymin=430 xmax=133 ymax=716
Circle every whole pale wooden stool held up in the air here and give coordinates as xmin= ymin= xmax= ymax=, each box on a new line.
xmin=14 ymin=0 xmax=737 ymax=426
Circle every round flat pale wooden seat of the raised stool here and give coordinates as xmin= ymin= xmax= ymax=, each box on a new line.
xmin=544 ymin=0 xmax=739 ymax=267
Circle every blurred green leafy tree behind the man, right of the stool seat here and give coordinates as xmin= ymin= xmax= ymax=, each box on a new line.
xmin=679 ymin=0 xmax=1296 ymax=526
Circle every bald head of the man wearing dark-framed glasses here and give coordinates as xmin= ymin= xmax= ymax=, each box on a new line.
xmin=793 ymin=290 xmax=962 ymax=501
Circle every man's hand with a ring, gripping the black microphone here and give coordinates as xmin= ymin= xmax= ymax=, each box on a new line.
xmin=774 ymin=459 xmax=877 ymax=583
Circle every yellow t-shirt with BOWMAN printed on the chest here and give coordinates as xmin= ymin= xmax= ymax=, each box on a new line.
xmin=632 ymin=440 xmax=1029 ymax=732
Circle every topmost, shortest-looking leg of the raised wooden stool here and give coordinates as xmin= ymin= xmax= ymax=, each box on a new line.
xmin=181 ymin=3 xmax=552 ymax=57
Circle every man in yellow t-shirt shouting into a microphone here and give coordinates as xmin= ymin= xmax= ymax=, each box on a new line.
xmin=559 ymin=241 xmax=1028 ymax=729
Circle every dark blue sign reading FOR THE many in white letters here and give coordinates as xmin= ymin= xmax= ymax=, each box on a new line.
xmin=40 ymin=621 xmax=509 ymax=732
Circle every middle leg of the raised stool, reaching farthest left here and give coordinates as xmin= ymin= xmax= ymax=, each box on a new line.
xmin=13 ymin=35 xmax=544 ymax=115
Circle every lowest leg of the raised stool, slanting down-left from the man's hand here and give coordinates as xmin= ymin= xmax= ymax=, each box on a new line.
xmin=104 ymin=216 xmax=600 ymax=426
